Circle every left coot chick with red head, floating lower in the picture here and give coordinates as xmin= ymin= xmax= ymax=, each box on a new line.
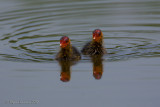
xmin=56 ymin=36 xmax=81 ymax=61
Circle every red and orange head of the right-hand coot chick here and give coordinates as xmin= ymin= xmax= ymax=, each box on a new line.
xmin=93 ymin=29 xmax=103 ymax=42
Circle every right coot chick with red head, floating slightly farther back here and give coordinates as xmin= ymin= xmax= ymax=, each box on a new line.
xmin=81 ymin=29 xmax=106 ymax=55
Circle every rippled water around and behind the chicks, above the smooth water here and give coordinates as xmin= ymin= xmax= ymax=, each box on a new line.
xmin=0 ymin=0 xmax=160 ymax=62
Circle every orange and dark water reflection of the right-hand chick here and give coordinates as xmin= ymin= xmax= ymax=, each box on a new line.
xmin=91 ymin=55 xmax=103 ymax=79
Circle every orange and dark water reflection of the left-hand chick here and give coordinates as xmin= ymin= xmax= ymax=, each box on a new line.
xmin=59 ymin=61 xmax=71 ymax=82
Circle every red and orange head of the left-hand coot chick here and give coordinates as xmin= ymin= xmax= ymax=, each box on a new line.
xmin=60 ymin=36 xmax=70 ymax=48
